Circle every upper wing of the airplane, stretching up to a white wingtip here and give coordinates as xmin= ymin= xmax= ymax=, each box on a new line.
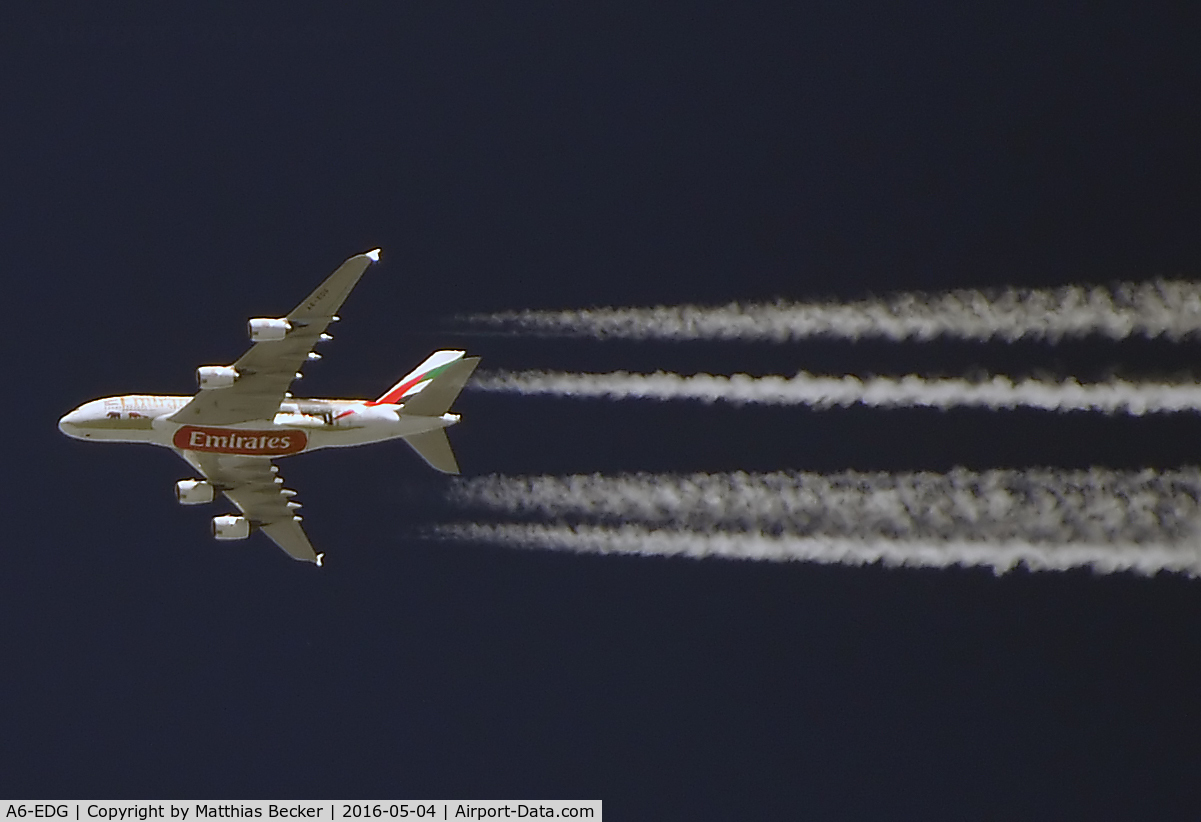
xmin=172 ymin=249 xmax=380 ymax=425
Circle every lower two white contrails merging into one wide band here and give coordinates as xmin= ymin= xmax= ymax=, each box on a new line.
xmin=431 ymin=467 xmax=1201 ymax=576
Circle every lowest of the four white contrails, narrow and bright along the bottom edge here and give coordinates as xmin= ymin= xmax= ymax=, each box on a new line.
xmin=431 ymin=524 xmax=1201 ymax=576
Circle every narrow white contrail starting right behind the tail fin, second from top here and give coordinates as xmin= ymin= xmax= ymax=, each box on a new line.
xmin=470 ymin=371 xmax=1201 ymax=416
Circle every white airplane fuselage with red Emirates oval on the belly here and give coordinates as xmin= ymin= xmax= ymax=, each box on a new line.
xmin=59 ymin=394 xmax=459 ymax=458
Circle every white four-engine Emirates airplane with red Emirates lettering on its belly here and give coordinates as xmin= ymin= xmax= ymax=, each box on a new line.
xmin=59 ymin=249 xmax=479 ymax=566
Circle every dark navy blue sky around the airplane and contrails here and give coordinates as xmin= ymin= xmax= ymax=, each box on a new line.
xmin=7 ymin=2 xmax=1201 ymax=820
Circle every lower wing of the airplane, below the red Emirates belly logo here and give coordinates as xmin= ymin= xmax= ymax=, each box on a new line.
xmin=179 ymin=451 xmax=322 ymax=565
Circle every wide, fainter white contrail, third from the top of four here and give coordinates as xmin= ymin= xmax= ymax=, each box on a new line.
xmin=447 ymin=467 xmax=1201 ymax=548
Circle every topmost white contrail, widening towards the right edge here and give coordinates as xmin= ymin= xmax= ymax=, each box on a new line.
xmin=459 ymin=280 xmax=1201 ymax=343
